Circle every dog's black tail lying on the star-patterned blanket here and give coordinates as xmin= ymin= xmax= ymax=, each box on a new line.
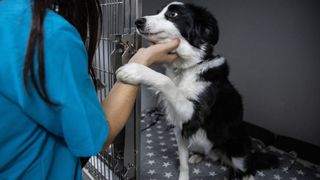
xmin=249 ymin=152 xmax=279 ymax=170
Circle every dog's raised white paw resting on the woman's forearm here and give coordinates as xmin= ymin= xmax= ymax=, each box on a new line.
xmin=116 ymin=63 xmax=147 ymax=85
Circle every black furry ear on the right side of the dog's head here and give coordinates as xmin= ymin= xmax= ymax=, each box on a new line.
xmin=187 ymin=4 xmax=219 ymax=46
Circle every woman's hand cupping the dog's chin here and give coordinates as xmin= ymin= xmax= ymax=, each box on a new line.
xmin=129 ymin=39 xmax=180 ymax=66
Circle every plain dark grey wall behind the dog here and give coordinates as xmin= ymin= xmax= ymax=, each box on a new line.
xmin=142 ymin=0 xmax=320 ymax=146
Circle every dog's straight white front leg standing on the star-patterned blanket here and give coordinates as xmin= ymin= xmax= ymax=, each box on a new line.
xmin=175 ymin=128 xmax=189 ymax=180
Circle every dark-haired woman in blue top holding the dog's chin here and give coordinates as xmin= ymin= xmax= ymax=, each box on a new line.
xmin=0 ymin=0 xmax=178 ymax=179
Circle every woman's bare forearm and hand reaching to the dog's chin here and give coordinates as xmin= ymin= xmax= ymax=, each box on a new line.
xmin=103 ymin=40 xmax=179 ymax=149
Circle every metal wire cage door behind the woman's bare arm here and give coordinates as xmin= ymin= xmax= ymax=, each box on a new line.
xmin=84 ymin=0 xmax=141 ymax=180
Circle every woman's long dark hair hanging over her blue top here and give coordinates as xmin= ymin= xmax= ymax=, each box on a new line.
xmin=23 ymin=0 xmax=102 ymax=104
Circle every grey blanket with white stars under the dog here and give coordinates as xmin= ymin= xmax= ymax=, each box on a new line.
xmin=140 ymin=110 xmax=320 ymax=180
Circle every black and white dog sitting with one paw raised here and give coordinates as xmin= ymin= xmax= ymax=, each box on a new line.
xmin=117 ymin=2 xmax=277 ymax=180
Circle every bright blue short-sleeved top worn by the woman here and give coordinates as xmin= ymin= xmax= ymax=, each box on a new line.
xmin=0 ymin=0 xmax=108 ymax=180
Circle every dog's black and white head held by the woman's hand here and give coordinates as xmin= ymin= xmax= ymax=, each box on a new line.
xmin=135 ymin=2 xmax=219 ymax=66
